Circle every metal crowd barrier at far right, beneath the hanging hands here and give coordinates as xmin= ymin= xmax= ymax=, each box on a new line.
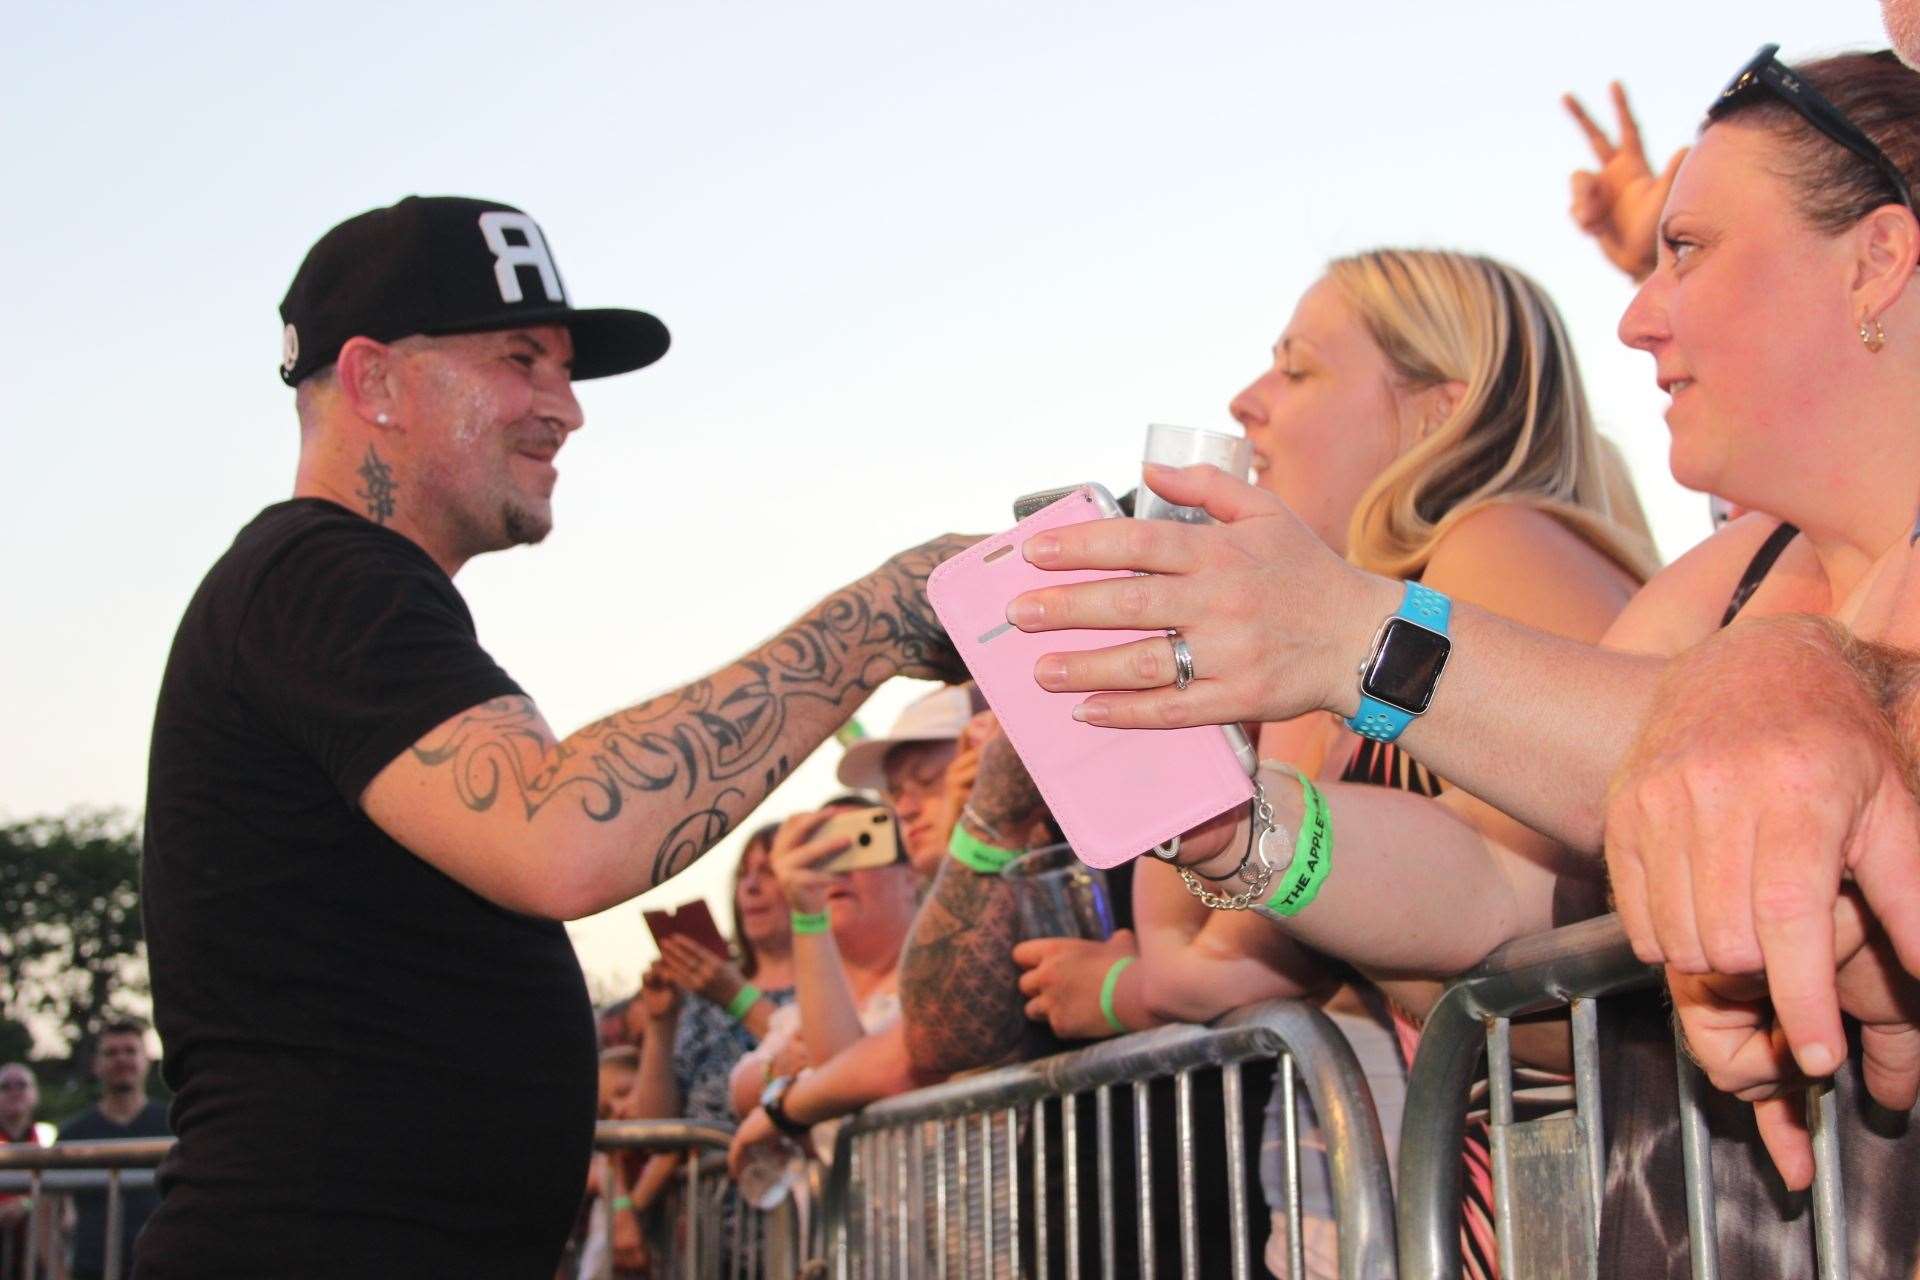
xmin=1400 ymin=915 xmax=1847 ymax=1280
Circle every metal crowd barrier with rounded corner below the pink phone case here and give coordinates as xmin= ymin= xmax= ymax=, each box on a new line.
xmin=826 ymin=1000 xmax=1394 ymax=1280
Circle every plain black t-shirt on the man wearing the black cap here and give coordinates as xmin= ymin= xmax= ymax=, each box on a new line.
xmin=136 ymin=499 xmax=595 ymax=1280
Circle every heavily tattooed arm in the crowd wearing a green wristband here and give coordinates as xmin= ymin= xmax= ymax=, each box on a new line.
xmin=900 ymin=735 xmax=1048 ymax=1077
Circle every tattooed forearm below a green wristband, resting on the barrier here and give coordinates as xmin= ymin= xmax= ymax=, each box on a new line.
xmin=900 ymin=858 xmax=1041 ymax=1077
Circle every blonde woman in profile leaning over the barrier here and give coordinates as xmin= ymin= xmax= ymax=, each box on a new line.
xmin=1016 ymin=249 xmax=1655 ymax=1274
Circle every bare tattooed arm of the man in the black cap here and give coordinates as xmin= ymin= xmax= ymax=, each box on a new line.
xmin=361 ymin=537 xmax=966 ymax=919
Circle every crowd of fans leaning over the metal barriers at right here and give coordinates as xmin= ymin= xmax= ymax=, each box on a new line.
xmin=568 ymin=25 xmax=1920 ymax=1276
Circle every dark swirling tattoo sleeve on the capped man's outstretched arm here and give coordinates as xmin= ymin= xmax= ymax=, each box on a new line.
xmin=413 ymin=535 xmax=972 ymax=885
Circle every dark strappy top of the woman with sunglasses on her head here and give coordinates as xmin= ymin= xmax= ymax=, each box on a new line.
xmin=1599 ymin=524 xmax=1920 ymax=1280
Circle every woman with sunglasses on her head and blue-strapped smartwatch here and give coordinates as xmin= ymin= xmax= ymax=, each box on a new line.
xmin=1010 ymin=50 xmax=1920 ymax=1274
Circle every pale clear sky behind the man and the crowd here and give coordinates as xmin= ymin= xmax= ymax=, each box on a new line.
xmin=0 ymin=0 xmax=1884 ymax=992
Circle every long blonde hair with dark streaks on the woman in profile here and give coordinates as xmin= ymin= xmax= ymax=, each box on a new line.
xmin=1327 ymin=249 xmax=1659 ymax=581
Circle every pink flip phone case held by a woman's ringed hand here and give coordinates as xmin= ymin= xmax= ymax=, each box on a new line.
xmin=927 ymin=489 xmax=1254 ymax=867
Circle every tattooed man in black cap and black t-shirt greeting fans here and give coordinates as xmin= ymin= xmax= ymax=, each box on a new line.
xmin=134 ymin=196 xmax=964 ymax=1280
